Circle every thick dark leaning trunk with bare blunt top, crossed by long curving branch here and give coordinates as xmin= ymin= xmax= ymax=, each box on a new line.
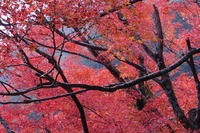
xmin=150 ymin=5 xmax=193 ymax=129
